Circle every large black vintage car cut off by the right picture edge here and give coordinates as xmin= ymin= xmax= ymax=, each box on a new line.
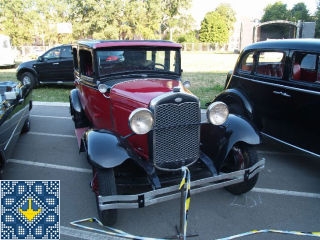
xmin=215 ymin=39 xmax=320 ymax=156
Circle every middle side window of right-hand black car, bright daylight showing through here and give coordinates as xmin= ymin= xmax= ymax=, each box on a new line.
xmin=255 ymin=51 xmax=285 ymax=78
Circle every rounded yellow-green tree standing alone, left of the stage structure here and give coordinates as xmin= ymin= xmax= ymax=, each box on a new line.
xmin=199 ymin=4 xmax=236 ymax=46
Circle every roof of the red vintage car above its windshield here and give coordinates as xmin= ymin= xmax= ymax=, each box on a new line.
xmin=73 ymin=40 xmax=182 ymax=49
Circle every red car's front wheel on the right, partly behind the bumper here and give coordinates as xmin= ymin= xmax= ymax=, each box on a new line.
xmin=223 ymin=144 xmax=259 ymax=195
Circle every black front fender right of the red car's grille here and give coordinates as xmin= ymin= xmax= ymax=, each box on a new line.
xmin=201 ymin=114 xmax=261 ymax=170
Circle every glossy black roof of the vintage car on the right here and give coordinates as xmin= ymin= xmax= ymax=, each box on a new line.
xmin=243 ymin=38 xmax=320 ymax=51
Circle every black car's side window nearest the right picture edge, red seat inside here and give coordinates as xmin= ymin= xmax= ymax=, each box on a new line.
xmin=291 ymin=52 xmax=320 ymax=83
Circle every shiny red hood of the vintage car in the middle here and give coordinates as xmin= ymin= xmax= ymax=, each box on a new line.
xmin=110 ymin=79 xmax=180 ymax=107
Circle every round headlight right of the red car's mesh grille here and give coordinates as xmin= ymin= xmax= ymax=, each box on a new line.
xmin=207 ymin=102 xmax=229 ymax=125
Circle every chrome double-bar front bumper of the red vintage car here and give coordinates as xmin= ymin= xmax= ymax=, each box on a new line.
xmin=98 ymin=159 xmax=265 ymax=210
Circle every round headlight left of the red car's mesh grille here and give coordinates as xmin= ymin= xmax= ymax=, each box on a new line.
xmin=129 ymin=108 xmax=153 ymax=134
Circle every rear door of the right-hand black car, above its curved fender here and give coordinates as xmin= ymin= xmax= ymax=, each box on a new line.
xmin=233 ymin=50 xmax=288 ymax=141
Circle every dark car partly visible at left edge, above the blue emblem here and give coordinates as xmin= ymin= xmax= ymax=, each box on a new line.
xmin=0 ymin=81 xmax=32 ymax=179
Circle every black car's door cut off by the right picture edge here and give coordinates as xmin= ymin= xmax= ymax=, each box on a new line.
xmin=282 ymin=51 xmax=320 ymax=155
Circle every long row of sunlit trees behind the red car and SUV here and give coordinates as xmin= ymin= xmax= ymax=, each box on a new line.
xmin=0 ymin=0 xmax=193 ymax=46
